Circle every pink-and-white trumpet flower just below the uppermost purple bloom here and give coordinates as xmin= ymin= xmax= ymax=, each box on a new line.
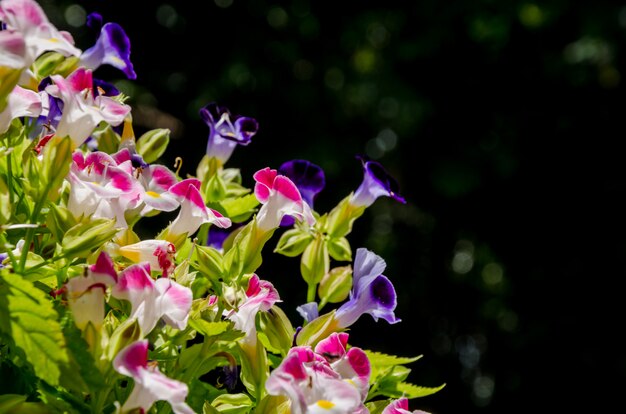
xmin=46 ymin=67 xmax=130 ymax=146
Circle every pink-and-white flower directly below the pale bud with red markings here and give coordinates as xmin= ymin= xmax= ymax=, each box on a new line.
xmin=111 ymin=263 xmax=192 ymax=335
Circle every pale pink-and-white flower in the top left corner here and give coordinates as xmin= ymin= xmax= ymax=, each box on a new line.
xmin=0 ymin=0 xmax=81 ymax=68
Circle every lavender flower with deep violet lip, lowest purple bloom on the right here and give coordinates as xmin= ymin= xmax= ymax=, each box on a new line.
xmin=335 ymin=248 xmax=400 ymax=328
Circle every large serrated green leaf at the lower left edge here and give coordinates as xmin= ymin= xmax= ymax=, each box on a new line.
xmin=0 ymin=272 xmax=69 ymax=385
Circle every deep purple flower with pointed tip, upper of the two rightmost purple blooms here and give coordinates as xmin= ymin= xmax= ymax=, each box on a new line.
xmin=350 ymin=157 xmax=406 ymax=207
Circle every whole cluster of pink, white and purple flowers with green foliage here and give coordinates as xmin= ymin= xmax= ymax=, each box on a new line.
xmin=0 ymin=0 xmax=442 ymax=414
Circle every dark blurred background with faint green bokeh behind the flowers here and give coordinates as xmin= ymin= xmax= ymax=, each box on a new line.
xmin=43 ymin=0 xmax=626 ymax=414
